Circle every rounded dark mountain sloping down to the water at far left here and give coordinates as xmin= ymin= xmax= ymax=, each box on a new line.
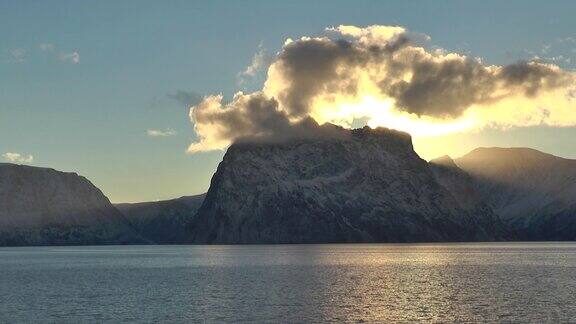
xmin=0 ymin=163 xmax=145 ymax=245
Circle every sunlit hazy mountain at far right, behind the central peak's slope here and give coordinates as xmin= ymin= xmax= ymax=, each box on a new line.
xmin=455 ymin=148 xmax=576 ymax=240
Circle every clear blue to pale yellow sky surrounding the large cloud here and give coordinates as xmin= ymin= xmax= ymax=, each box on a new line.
xmin=0 ymin=0 xmax=576 ymax=202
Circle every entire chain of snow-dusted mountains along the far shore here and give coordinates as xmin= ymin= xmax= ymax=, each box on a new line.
xmin=0 ymin=132 xmax=576 ymax=245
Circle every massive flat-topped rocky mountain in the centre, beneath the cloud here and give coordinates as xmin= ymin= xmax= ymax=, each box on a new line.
xmin=189 ymin=126 xmax=508 ymax=243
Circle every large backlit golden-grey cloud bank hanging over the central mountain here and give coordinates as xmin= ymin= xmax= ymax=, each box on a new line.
xmin=189 ymin=26 xmax=576 ymax=152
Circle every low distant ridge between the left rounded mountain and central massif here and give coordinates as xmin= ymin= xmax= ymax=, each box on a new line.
xmin=115 ymin=194 xmax=205 ymax=244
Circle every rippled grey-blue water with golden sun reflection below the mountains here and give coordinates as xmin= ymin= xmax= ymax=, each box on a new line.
xmin=0 ymin=243 xmax=576 ymax=322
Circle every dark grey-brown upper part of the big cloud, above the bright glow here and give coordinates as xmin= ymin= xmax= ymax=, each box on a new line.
xmin=273 ymin=36 xmax=572 ymax=118
